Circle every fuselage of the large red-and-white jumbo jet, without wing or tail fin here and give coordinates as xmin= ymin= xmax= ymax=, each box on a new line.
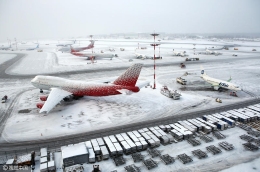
xmin=31 ymin=75 xmax=139 ymax=96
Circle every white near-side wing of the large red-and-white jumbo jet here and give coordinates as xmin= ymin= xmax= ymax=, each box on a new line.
xmin=40 ymin=88 xmax=72 ymax=113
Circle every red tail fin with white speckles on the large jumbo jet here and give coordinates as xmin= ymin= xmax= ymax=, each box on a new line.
xmin=113 ymin=63 xmax=143 ymax=87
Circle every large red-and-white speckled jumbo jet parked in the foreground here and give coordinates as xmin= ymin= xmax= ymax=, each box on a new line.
xmin=31 ymin=64 xmax=148 ymax=113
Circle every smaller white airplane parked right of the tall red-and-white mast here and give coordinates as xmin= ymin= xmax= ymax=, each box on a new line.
xmin=200 ymin=69 xmax=242 ymax=91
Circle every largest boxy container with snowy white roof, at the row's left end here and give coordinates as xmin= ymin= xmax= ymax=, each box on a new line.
xmin=61 ymin=143 xmax=89 ymax=167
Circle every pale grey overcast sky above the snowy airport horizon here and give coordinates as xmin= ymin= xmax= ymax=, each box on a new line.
xmin=0 ymin=0 xmax=260 ymax=40
